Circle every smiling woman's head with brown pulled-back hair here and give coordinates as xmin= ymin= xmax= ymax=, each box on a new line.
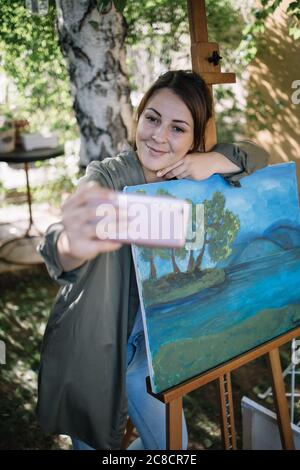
xmin=135 ymin=71 xmax=212 ymax=182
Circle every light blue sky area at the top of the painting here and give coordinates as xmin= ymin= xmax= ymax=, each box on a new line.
xmin=126 ymin=162 xmax=300 ymax=278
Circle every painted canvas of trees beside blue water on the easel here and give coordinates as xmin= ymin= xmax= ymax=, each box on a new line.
xmin=125 ymin=163 xmax=300 ymax=393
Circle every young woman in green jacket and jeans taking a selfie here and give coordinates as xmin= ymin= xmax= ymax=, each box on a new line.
xmin=38 ymin=71 xmax=266 ymax=449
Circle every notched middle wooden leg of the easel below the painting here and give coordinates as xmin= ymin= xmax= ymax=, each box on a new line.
xmin=219 ymin=372 xmax=236 ymax=450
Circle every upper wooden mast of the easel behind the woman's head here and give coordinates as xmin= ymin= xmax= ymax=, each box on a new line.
xmin=187 ymin=0 xmax=235 ymax=151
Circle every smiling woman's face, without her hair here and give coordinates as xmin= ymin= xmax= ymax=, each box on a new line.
xmin=136 ymin=88 xmax=194 ymax=182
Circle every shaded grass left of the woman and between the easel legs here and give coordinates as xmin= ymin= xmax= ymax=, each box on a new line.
xmin=0 ymin=266 xmax=300 ymax=449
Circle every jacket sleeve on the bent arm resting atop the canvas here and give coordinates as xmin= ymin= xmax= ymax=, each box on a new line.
xmin=212 ymin=140 xmax=269 ymax=187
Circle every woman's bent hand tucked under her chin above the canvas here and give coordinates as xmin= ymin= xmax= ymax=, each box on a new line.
xmin=157 ymin=152 xmax=241 ymax=180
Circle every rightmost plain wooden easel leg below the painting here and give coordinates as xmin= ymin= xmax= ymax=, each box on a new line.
xmin=268 ymin=348 xmax=295 ymax=450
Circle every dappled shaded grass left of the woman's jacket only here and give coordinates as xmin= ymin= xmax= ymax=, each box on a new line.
xmin=0 ymin=266 xmax=68 ymax=449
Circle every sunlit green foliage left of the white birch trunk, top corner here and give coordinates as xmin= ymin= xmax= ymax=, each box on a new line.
xmin=0 ymin=0 xmax=76 ymax=138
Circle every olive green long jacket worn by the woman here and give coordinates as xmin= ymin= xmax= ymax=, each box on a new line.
xmin=37 ymin=142 xmax=267 ymax=449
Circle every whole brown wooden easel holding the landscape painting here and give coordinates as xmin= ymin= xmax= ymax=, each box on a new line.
xmin=122 ymin=0 xmax=300 ymax=450
